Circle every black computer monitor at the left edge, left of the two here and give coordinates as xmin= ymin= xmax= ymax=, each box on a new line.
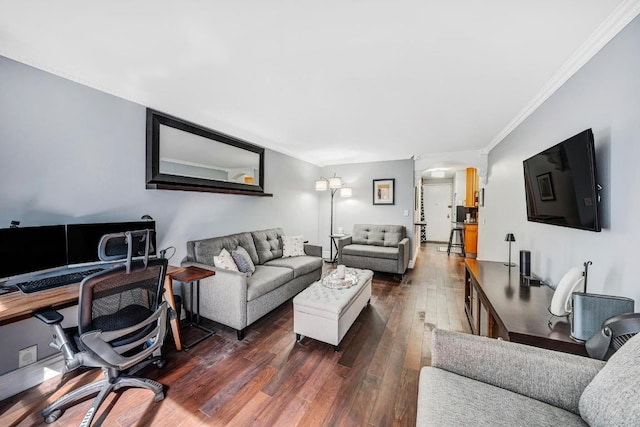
xmin=0 ymin=225 xmax=67 ymax=280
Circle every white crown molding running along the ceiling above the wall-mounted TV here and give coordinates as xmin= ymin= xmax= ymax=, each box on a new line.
xmin=482 ymin=0 xmax=640 ymax=154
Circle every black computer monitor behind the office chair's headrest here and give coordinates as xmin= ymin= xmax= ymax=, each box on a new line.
xmin=67 ymin=221 xmax=156 ymax=265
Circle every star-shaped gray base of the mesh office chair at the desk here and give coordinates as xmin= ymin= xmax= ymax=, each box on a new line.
xmin=41 ymin=358 xmax=164 ymax=426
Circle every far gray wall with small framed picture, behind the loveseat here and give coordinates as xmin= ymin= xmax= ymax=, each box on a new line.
xmin=318 ymin=160 xmax=414 ymax=256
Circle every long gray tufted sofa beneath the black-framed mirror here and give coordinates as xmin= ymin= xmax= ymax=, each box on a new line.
xmin=182 ymin=228 xmax=322 ymax=340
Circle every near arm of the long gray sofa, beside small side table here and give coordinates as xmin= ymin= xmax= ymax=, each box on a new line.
xmin=181 ymin=261 xmax=247 ymax=330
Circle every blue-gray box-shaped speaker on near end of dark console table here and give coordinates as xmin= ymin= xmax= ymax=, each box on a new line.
xmin=570 ymin=292 xmax=634 ymax=341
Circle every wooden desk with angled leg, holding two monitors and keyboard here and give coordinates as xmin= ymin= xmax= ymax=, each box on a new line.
xmin=0 ymin=265 xmax=184 ymax=350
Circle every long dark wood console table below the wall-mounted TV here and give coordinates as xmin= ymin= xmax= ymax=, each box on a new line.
xmin=464 ymin=259 xmax=587 ymax=356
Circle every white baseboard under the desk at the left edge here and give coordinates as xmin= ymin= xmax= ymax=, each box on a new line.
xmin=0 ymin=353 xmax=65 ymax=400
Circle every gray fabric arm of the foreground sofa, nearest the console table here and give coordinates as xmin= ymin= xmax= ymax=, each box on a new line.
xmin=431 ymin=329 xmax=604 ymax=415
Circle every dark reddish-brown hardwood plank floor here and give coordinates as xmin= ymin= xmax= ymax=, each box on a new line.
xmin=0 ymin=244 xmax=469 ymax=426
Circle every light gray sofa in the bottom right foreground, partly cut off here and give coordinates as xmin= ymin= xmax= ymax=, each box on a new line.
xmin=416 ymin=329 xmax=640 ymax=427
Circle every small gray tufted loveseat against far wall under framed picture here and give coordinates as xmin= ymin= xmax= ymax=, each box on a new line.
xmin=338 ymin=224 xmax=410 ymax=275
